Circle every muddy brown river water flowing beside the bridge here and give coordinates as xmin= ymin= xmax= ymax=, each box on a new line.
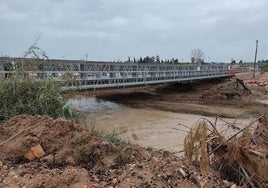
xmin=68 ymin=98 xmax=250 ymax=154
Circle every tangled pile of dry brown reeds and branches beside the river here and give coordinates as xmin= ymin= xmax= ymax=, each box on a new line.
xmin=184 ymin=116 xmax=268 ymax=187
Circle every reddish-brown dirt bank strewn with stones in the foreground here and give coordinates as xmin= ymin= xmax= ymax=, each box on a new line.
xmin=0 ymin=115 xmax=231 ymax=188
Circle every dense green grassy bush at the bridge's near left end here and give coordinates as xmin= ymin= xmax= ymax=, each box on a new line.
xmin=0 ymin=77 xmax=72 ymax=122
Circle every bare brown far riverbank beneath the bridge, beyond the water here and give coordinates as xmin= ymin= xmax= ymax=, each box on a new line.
xmin=72 ymin=73 xmax=268 ymax=118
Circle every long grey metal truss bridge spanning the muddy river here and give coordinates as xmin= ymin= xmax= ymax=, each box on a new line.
xmin=0 ymin=58 xmax=231 ymax=90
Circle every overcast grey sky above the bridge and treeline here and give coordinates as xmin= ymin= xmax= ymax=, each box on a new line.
xmin=0 ymin=0 xmax=268 ymax=62
